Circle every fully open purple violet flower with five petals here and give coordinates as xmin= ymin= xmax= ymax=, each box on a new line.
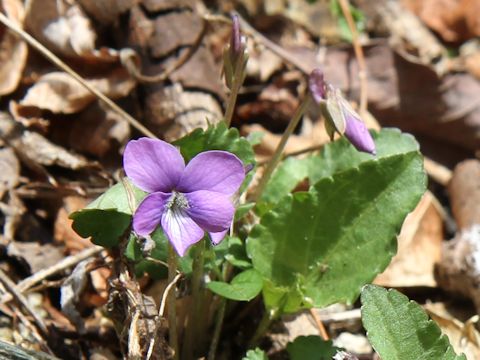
xmin=123 ymin=138 xmax=245 ymax=256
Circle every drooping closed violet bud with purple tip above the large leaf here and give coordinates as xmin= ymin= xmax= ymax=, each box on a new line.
xmin=308 ymin=69 xmax=376 ymax=155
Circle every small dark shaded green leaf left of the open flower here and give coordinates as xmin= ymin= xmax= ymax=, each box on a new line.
xmin=70 ymin=209 xmax=132 ymax=247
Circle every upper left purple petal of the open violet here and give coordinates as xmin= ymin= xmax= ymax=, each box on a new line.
xmin=123 ymin=138 xmax=185 ymax=192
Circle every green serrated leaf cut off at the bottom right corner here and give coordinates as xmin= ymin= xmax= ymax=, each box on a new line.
xmin=361 ymin=285 xmax=466 ymax=360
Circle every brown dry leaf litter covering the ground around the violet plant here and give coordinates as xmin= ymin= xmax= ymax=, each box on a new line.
xmin=0 ymin=0 xmax=480 ymax=358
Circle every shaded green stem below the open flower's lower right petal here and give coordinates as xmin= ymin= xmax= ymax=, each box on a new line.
xmin=182 ymin=240 xmax=205 ymax=360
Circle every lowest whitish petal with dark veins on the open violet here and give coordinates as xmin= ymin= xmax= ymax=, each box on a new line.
xmin=162 ymin=210 xmax=205 ymax=256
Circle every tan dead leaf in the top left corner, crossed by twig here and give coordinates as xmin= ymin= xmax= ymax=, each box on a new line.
xmin=0 ymin=0 xmax=28 ymax=95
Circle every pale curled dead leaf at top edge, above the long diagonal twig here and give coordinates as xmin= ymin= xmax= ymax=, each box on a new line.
xmin=25 ymin=0 xmax=96 ymax=57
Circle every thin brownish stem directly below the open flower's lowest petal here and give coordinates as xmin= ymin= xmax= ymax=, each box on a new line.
xmin=167 ymin=245 xmax=179 ymax=360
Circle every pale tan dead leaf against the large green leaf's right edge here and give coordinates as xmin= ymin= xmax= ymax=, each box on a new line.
xmin=375 ymin=192 xmax=443 ymax=287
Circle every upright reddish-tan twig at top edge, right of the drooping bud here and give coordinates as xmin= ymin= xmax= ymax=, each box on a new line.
xmin=339 ymin=0 xmax=368 ymax=115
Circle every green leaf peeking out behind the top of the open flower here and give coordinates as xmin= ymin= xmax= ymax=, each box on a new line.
xmin=174 ymin=122 xmax=255 ymax=165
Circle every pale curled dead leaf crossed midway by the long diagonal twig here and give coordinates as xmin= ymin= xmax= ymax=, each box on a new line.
xmin=18 ymin=69 xmax=135 ymax=114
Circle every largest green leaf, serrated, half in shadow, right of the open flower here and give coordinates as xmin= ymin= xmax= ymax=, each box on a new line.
xmin=247 ymin=143 xmax=426 ymax=312
